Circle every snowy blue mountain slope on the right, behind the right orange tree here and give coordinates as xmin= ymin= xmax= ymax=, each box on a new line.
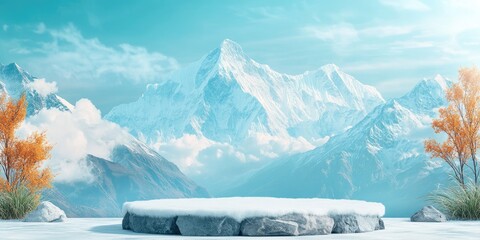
xmin=225 ymin=76 xmax=451 ymax=217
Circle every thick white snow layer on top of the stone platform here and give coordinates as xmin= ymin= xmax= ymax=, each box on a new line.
xmin=123 ymin=197 xmax=385 ymax=222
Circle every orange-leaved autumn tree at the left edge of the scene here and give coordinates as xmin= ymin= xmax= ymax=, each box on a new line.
xmin=0 ymin=94 xmax=52 ymax=193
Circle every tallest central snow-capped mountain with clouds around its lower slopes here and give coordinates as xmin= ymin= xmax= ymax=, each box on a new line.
xmin=105 ymin=40 xmax=384 ymax=194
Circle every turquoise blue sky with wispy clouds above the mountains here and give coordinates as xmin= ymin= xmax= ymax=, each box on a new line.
xmin=0 ymin=0 xmax=480 ymax=114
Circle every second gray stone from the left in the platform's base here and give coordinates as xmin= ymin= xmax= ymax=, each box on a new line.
xmin=177 ymin=216 xmax=240 ymax=236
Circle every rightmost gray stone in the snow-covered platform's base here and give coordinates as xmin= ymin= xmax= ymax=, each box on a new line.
xmin=332 ymin=215 xmax=385 ymax=233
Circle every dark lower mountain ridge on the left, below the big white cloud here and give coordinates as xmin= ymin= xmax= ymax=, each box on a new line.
xmin=43 ymin=140 xmax=209 ymax=217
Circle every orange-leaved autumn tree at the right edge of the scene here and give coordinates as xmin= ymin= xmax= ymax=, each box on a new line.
xmin=425 ymin=67 xmax=480 ymax=186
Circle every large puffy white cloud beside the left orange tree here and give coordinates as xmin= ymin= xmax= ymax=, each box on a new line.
xmin=19 ymin=99 xmax=130 ymax=183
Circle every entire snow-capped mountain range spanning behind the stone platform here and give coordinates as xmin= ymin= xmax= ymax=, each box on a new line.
xmin=0 ymin=40 xmax=452 ymax=217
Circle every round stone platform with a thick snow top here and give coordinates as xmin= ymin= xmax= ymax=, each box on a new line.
xmin=122 ymin=197 xmax=385 ymax=236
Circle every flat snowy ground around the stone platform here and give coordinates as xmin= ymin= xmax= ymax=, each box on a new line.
xmin=0 ymin=218 xmax=480 ymax=240
